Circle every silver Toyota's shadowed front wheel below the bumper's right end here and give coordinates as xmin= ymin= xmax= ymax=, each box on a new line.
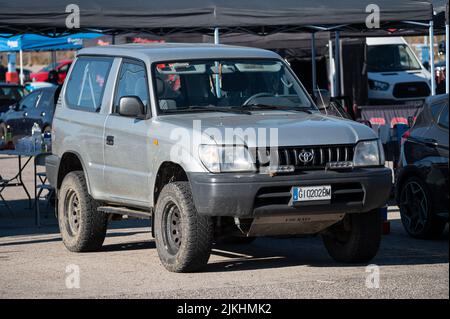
xmin=322 ymin=209 xmax=382 ymax=263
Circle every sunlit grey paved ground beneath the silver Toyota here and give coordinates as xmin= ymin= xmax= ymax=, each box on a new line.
xmin=0 ymin=159 xmax=449 ymax=299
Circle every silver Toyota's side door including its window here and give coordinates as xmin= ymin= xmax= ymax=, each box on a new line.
xmin=104 ymin=59 xmax=150 ymax=207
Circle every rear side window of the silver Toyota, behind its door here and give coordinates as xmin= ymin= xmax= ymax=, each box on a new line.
xmin=66 ymin=57 xmax=113 ymax=112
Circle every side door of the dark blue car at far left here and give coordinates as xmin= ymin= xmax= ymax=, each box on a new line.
xmin=7 ymin=90 xmax=42 ymax=137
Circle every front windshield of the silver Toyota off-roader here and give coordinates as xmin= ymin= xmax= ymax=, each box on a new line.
xmin=153 ymin=59 xmax=314 ymax=113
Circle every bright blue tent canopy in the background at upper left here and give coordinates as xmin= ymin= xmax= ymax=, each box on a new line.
xmin=0 ymin=33 xmax=102 ymax=52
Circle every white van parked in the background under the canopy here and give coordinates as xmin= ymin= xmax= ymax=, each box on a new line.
xmin=366 ymin=37 xmax=431 ymax=105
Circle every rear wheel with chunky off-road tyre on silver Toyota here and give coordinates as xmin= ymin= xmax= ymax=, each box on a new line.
xmin=58 ymin=171 xmax=108 ymax=252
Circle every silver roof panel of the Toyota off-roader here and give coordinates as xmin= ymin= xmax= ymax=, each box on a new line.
xmin=78 ymin=43 xmax=280 ymax=62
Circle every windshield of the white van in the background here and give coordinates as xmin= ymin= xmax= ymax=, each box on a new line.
xmin=367 ymin=44 xmax=421 ymax=72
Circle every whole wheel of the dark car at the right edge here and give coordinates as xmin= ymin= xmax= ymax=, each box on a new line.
xmin=399 ymin=177 xmax=446 ymax=239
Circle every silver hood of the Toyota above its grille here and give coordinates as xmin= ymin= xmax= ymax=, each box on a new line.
xmin=158 ymin=111 xmax=377 ymax=147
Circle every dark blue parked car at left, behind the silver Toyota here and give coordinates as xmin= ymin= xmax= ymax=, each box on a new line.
xmin=0 ymin=87 xmax=61 ymax=139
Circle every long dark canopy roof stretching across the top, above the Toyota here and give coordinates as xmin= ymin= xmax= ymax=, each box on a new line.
xmin=0 ymin=0 xmax=442 ymax=35
